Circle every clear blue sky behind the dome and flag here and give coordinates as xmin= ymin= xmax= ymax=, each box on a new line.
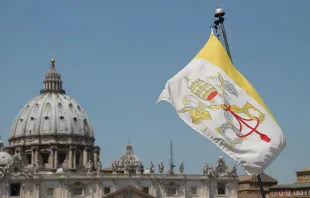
xmin=0 ymin=0 xmax=310 ymax=183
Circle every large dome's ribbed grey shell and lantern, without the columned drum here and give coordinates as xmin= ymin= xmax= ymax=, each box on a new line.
xmin=9 ymin=59 xmax=94 ymax=144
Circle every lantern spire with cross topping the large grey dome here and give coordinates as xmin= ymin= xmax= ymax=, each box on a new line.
xmin=40 ymin=57 xmax=66 ymax=94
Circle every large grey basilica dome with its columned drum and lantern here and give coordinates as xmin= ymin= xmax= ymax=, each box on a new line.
xmin=5 ymin=58 xmax=100 ymax=171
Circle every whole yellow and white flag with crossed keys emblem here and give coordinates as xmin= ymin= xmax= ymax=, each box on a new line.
xmin=157 ymin=34 xmax=286 ymax=174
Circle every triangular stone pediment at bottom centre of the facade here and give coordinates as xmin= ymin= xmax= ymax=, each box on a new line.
xmin=104 ymin=185 xmax=155 ymax=198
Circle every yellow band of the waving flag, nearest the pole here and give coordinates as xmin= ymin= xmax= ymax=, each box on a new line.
xmin=194 ymin=34 xmax=276 ymax=121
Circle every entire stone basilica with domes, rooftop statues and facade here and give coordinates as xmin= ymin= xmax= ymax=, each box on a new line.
xmin=0 ymin=59 xmax=238 ymax=198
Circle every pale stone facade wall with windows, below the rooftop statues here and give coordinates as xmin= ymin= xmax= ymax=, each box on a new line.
xmin=0 ymin=156 xmax=238 ymax=198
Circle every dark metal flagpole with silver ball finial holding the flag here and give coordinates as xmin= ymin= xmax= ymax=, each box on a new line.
xmin=214 ymin=7 xmax=266 ymax=198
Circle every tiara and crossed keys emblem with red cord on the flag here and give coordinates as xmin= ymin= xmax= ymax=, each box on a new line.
xmin=178 ymin=73 xmax=270 ymax=147
